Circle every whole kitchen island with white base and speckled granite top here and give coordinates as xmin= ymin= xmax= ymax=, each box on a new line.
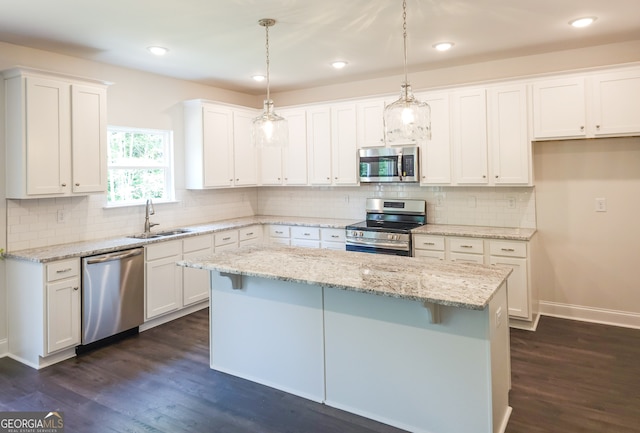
xmin=179 ymin=245 xmax=511 ymax=433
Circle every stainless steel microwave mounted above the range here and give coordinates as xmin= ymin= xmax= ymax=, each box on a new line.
xmin=358 ymin=146 xmax=420 ymax=183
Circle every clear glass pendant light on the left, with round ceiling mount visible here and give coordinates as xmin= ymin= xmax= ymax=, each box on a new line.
xmin=251 ymin=18 xmax=289 ymax=147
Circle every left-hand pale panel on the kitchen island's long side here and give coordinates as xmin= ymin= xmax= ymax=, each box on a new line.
xmin=210 ymin=271 xmax=324 ymax=402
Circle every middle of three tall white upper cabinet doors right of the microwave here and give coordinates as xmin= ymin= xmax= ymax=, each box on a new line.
xmin=452 ymin=89 xmax=488 ymax=185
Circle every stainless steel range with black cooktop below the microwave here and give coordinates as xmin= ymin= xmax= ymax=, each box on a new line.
xmin=346 ymin=198 xmax=427 ymax=256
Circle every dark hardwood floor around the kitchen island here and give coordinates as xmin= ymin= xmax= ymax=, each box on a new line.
xmin=0 ymin=310 xmax=640 ymax=433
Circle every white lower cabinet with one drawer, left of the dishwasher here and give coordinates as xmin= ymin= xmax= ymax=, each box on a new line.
xmin=6 ymin=258 xmax=81 ymax=368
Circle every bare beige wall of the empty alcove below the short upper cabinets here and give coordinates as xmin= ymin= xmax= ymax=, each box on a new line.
xmin=533 ymin=137 xmax=640 ymax=327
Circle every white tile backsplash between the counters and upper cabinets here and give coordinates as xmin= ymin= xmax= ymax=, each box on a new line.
xmin=7 ymin=184 xmax=536 ymax=251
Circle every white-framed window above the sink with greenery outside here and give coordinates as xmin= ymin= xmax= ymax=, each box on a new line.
xmin=107 ymin=126 xmax=174 ymax=206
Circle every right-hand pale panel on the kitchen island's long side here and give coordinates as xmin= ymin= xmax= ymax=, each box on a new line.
xmin=324 ymin=288 xmax=508 ymax=433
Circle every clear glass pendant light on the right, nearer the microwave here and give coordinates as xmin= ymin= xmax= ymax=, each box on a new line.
xmin=384 ymin=0 xmax=431 ymax=144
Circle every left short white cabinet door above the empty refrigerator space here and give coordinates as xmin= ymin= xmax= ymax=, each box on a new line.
xmin=533 ymin=78 xmax=587 ymax=139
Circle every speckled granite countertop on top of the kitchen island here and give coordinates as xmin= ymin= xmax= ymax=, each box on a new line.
xmin=178 ymin=245 xmax=512 ymax=310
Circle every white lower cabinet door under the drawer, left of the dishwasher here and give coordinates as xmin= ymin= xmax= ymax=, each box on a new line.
xmin=46 ymin=277 xmax=80 ymax=354
